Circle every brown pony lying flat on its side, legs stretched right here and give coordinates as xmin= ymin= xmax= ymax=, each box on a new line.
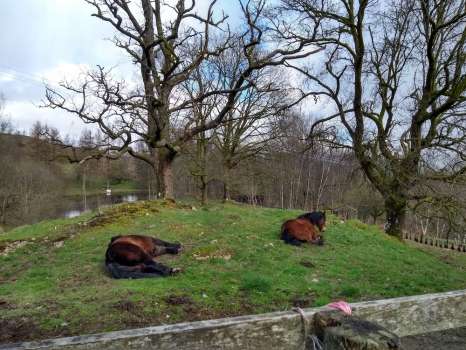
xmin=105 ymin=235 xmax=181 ymax=278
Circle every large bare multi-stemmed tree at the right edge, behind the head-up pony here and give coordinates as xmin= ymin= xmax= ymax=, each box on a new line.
xmin=275 ymin=0 xmax=466 ymax=237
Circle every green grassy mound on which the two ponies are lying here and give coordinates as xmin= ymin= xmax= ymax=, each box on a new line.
xmin=0 ymin=202 xmax=466 ymax=341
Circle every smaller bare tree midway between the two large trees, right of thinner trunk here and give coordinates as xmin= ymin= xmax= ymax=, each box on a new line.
xmin=213 ymin=51 xmax=294 ymax=200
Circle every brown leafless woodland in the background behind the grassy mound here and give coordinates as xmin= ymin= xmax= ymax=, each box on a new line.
xmin=0 ymin=113 xmax=466 ymax=245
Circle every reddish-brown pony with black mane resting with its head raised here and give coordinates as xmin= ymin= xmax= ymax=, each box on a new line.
xmin=280 ymin=212 xmax=326 ymax=246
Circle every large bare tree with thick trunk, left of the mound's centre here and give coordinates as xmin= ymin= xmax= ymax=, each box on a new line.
xmin=46 ymin=0 xmax=312 ymax=198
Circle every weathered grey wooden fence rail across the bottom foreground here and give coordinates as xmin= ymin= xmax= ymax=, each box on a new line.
xmin=0 ymin=290 xmax=466 ymax=350
